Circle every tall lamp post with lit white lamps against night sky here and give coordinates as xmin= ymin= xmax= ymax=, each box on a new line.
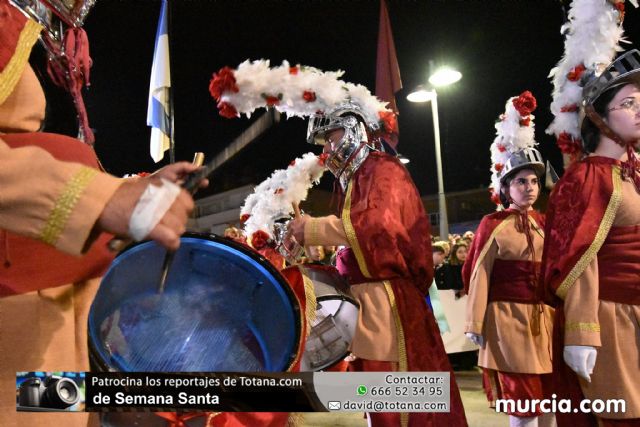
xmin=407 ymin=66 xmax=462 ymax=241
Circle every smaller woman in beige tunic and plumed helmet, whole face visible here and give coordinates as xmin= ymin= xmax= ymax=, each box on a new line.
xmin=463 ymin=92 xmax=553 ymax=426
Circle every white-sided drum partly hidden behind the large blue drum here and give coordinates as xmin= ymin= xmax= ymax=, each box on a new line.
xmin=300 ymin=264 xmax=359 ymax=371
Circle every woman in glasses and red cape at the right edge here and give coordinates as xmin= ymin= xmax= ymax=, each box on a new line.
xmin=542 ymin=50 xmax=640 ymax=426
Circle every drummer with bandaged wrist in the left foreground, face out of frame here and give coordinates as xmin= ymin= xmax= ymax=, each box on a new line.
xmin=0 ymin=0 xmax=202 ymax=426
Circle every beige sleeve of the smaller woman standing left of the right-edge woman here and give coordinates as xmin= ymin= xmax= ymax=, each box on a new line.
xmin=464 ymin=239 xmax=498 ymax=335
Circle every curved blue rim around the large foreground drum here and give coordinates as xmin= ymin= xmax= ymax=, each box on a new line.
xmin=87 ymin=231 xmax=304 ymax=372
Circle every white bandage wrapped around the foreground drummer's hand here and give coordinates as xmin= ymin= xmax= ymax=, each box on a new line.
xmin=129 ymin=178 xmax=181 ymax=241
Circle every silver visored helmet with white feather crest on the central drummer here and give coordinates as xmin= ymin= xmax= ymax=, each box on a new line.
xmin=209 ymin=60 xmax=398 ymax=182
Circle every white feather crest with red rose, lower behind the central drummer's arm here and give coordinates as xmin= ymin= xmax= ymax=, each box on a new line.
xmin=240 ymin=153 xmax=326 ymax=250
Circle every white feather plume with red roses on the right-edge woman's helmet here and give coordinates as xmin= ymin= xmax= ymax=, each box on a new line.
xmin=546 ymin=0 xmax=638 ymax=162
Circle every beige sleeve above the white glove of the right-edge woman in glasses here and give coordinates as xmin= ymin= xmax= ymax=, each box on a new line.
xmin=564 ymin=257 xmax=600 ymax=347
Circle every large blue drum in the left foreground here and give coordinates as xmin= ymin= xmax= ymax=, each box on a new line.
xmin=89 ymin=234 xmax=301 ymax=372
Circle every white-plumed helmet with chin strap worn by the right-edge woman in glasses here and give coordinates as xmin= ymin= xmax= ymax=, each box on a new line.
xmin=546 ymin=0 xmax=640 ymax=161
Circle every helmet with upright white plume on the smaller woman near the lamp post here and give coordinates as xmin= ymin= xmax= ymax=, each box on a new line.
xmin=489 ymin=91 xmax=545 ymax=208
